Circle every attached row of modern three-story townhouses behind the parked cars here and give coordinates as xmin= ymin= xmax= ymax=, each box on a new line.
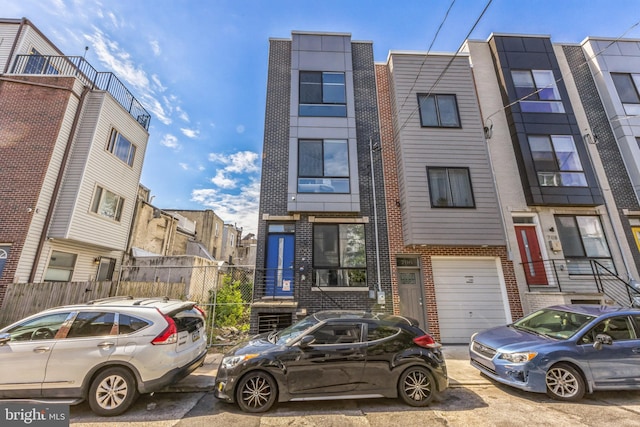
xmin=252 ymin=32 xmax=640 ymax=343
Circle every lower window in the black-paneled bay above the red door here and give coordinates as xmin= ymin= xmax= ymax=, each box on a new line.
xmin=529 ymin=135 xmax=587 ymax=187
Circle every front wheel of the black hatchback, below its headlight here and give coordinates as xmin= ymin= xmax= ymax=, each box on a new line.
xmin=236 ymin=371 xmax=278 ymax=412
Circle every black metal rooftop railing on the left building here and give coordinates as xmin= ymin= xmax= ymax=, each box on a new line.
xmin=9 ymin=55 xmax=151 ymax=130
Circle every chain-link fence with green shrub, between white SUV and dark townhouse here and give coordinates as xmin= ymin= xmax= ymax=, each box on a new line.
xmin=116 ymin=263 xmax=255 ymax=348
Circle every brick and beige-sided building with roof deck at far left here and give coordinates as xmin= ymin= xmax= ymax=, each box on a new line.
xmin=0 ymin=18 xmax=150 ymax=308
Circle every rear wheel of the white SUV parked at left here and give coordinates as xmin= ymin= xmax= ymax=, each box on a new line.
xmin=89 ymin=367 xmax=138 ymax=417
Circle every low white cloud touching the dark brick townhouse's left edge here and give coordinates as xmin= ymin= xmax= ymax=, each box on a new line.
xmin=191 ymin=179 xmax=260 ymax=235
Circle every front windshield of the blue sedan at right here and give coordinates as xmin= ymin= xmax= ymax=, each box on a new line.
xmin=513 ymin=308 xmax=595 ymax=339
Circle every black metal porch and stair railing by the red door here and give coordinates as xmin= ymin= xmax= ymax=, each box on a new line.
xmin=521 ymin=259 xmax=640 ymax=307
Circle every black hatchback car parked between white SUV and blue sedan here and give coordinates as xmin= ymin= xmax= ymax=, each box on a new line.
xmin=215 ymin=311 xmax=449 ymax=412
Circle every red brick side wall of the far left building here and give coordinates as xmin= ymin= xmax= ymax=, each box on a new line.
xmin=0 ymin=76 xmax=74 ymax=304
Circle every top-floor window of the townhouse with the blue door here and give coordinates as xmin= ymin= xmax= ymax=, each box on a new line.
xmin=298 ymin=71 xmax=347 ymax=117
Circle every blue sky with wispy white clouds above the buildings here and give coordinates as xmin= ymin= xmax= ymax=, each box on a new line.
xmin=5 ymin=0 xmax=640 ymax=235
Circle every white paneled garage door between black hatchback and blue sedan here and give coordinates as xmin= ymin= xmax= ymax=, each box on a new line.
xmin=432 ymin=257 xmax=510 ymax=344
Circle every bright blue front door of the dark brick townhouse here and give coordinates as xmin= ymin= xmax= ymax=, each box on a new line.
xmin=265 ymin=234 xmax=294 ymax=297
